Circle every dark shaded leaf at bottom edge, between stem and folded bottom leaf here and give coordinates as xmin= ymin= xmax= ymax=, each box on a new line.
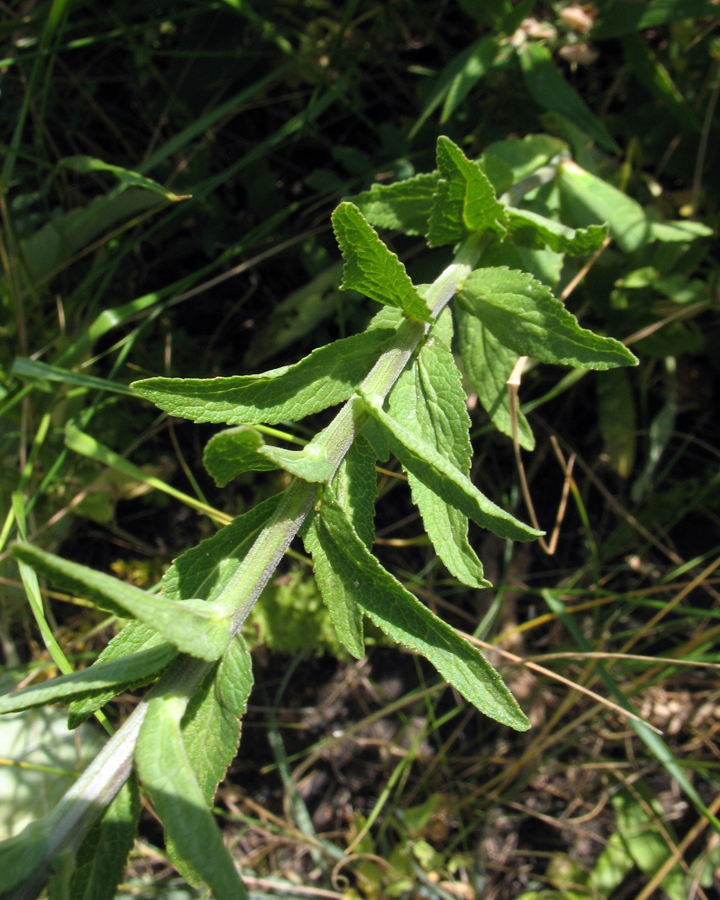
xmin=70 ymin=772 xmax=141 ymax=900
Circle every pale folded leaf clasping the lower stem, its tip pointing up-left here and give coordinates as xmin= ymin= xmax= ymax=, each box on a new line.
xmin=12 ymin=544 xmax=232 ymax=660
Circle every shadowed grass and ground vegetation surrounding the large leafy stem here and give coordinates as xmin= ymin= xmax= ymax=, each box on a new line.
xmin=0 ymin=0 xmax=720 ymax=900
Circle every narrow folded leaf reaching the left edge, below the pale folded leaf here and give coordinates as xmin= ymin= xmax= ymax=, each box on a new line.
xmin=0 ymin=642 xmax=177 ymax=714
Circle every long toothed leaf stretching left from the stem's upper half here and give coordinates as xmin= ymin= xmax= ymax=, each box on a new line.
xmin=132 ymin=320 xmax=396 ymax=425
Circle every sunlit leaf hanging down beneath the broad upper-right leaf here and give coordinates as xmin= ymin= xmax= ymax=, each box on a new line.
xmin=455 ymin=304 xmax=535 ymax=450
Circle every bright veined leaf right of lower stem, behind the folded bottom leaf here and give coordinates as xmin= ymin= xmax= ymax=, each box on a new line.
xmin=166 ymin=635 xmax=253 ymax=887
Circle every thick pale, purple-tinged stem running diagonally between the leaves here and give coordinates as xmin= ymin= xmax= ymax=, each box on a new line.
xmin=8 ymin=235 xmax=492 ymax=900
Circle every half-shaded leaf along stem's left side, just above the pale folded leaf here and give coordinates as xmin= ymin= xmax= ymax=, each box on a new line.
xmin=162 ymin=493 xmax=284 ymax=602
